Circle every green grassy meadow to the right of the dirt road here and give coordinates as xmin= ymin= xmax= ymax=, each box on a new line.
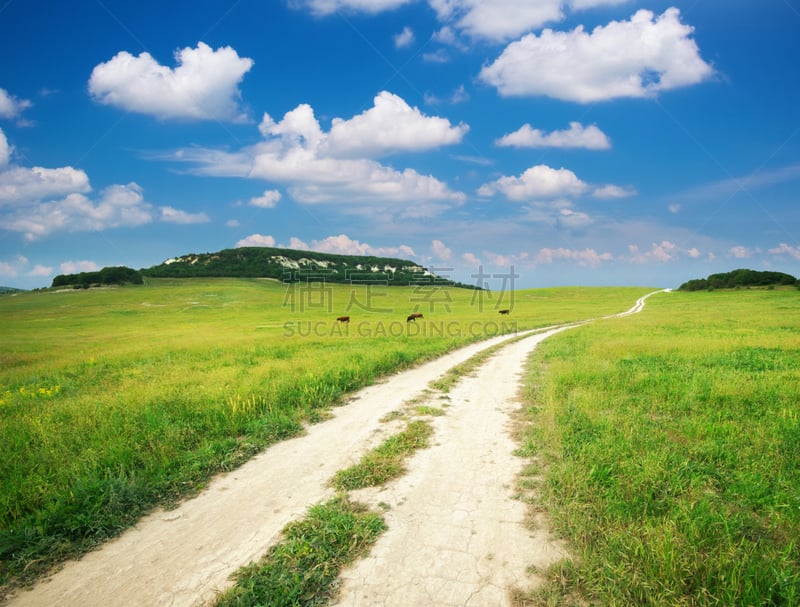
xmin=519 ymin=289 xmax=800 ymax=606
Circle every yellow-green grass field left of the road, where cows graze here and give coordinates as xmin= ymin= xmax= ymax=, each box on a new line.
xmin=0 ymin=279 xmax=652 ymax=585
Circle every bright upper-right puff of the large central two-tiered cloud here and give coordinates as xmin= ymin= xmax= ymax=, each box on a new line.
xmin=327 ymin=91 xmax=469 ymax=157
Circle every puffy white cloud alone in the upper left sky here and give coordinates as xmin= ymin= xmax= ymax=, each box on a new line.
xmin=89 ymin=42 xmax=253 ymax=121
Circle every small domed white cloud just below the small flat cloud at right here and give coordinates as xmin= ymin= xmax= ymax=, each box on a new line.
xmin=478 ymin=164 xmax=589 ymax=201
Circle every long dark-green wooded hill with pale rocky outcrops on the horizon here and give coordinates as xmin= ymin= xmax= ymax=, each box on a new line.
xmin=141 ymin=247 xmax=474 ymax=288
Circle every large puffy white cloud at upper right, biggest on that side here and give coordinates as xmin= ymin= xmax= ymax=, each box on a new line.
xmin=480 ymin=8 xmax=713 ymax=103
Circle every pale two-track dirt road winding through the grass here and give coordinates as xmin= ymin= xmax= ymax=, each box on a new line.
xmin=9 ymin=292 xmax=664 ymax=607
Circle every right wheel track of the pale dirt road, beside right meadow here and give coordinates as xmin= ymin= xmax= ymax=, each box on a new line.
xmin=336 ymin=329 xmax=566 ymax=607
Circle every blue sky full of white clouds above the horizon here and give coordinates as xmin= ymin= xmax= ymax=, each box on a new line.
xmin=0 ymin=0 xmax=800 ymax=289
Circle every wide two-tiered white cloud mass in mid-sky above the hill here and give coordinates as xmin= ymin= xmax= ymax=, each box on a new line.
xmin=178 ymin=93 xmax=466 ymax=205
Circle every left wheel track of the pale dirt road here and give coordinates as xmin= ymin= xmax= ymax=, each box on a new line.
xmin=8 ymin=336 xmax=536 ymax=607
